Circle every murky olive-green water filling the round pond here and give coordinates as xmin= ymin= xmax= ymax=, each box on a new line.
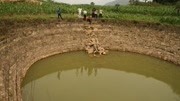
xmin=22 ymin=51 xmax=180 ymax=101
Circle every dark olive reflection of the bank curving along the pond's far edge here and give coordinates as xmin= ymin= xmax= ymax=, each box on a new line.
xmin=22 ymin=51 xmax=180 ymax=95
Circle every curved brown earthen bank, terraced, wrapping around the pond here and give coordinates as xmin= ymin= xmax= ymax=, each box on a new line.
xmin=0 ymin=22 xmax=180 ymax=101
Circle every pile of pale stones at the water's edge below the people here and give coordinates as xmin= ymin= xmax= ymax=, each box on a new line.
xmin=85 ymin=38 xmax=107 ymax=55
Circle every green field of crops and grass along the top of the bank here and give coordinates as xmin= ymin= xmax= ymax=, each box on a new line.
xmin=0 ymin=3 xmax=180 ymax=25
